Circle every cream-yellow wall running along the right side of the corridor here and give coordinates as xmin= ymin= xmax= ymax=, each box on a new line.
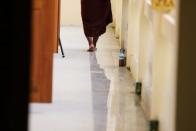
xmin=112 ymin=0 xmax=177 ymax=131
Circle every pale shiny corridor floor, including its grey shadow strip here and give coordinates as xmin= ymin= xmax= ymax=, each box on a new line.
xmin=29 ymin=26 xmax=148 ymax=131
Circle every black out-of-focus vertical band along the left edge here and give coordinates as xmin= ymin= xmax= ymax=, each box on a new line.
xmin=0 ymin=0 xmax=31 ymax=131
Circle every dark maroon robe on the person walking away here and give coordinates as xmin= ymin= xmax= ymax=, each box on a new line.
xmin=81 ymin=0 xmax=112 ymax=37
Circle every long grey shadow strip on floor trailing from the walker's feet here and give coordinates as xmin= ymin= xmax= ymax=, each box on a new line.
xmin=89 ymin=53 xmax=110 ymax=131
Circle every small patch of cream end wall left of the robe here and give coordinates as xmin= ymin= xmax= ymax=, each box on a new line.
xmin=61 ymin=0 xmax=82 ymax=26
